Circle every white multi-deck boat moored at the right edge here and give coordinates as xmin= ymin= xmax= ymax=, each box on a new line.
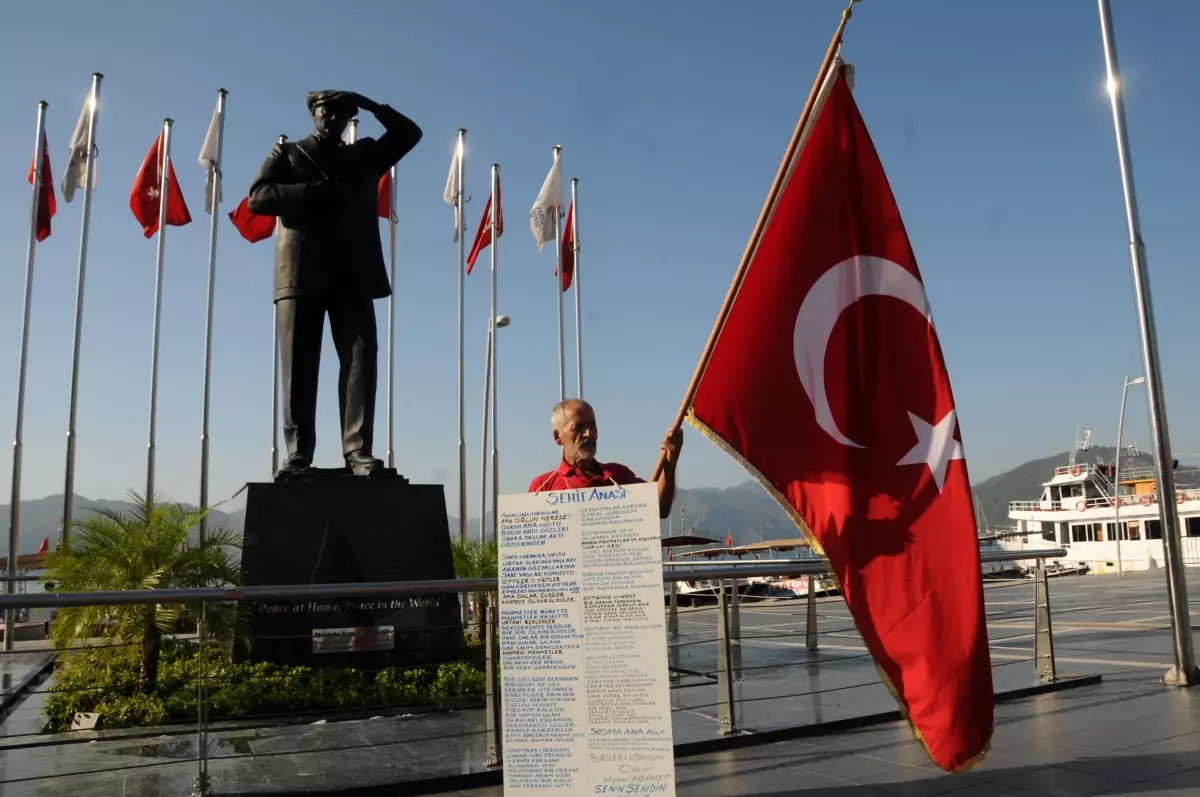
xmin=995 ymin=430 xmax=1200 ymax=575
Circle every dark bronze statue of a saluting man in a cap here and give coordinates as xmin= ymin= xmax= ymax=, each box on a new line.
xmin=248 ymin=91 xmax=421 ymax=475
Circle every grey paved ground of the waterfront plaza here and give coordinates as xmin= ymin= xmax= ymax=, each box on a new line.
xmin=0 ymin=570 xmax=1200 ymax=797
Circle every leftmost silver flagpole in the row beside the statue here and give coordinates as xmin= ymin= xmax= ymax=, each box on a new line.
xmin=4 ymin=100 xmax=49 ymax=651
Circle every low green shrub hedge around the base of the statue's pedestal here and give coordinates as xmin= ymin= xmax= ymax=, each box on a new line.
xmin=44 ymin=640 xmax=486 ymax=731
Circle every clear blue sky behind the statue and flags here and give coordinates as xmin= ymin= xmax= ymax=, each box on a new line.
xmin=0 ymin=0 xmax=1200 ymax=514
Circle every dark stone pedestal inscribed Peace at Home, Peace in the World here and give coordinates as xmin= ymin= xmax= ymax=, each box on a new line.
xmin=234 ymin=473 xmax=464 ymax=670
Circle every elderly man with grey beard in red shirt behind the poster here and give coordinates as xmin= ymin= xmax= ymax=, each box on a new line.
xmin=529 ymin=399 xmax=683 ymax=517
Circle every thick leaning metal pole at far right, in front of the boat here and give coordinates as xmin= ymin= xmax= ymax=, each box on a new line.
xmin=1098 ymin=0 xmax=1200 ymax=687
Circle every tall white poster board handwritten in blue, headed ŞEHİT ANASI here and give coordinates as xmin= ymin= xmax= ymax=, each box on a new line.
xmin=499 ymin=484 xmax=676 ymax=797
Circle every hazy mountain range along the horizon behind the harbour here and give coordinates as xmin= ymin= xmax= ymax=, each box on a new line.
xmin=0 ymin=447 xmax=1190 ymax=552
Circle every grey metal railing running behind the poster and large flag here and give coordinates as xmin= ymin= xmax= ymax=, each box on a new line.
xmin=0 ymin=549 xmax=1067 ymax=796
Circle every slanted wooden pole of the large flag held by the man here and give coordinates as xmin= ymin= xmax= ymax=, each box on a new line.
xmin=650 ymin=0 xmax=858 ymax=481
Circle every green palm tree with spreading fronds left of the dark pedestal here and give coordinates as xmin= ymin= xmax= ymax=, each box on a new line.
xmin=42 ymin=492 xmax=241 ymax=690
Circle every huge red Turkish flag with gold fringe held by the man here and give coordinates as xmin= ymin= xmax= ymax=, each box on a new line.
xmin=689 ymin=68 xmax=994 ymax=771
